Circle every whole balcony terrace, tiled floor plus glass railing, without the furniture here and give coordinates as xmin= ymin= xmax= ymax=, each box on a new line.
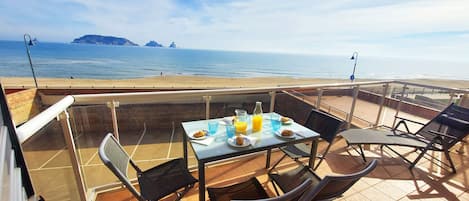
xmin=10 ymin=81 xmax=469 ymax=200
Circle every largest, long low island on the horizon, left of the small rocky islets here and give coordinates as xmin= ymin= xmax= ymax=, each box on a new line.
xmin=72 ymin=35 xmax=138 ymax=46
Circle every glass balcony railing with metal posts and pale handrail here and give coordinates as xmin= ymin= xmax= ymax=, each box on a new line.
xmin=14 ymin=81 xmax=468 ymax=200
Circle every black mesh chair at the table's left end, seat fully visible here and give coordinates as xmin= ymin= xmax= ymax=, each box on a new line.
xmin=99 ymin=133 xmax=197 ymax=201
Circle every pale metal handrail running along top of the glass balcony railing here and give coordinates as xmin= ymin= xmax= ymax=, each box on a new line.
xmin=17 ymin=80 xmax=469 ymax=143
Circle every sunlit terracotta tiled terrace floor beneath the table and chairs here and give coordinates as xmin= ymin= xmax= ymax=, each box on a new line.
xmin=97 ymin=139 xmax=469 ymax=201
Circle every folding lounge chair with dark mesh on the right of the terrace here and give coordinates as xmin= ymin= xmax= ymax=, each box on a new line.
xmin=340 ymin=104 xmax=469 ymax=173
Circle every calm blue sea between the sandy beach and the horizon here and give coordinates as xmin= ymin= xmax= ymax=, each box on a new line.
xmin=0 ymin=41 xmax=469 ymax=80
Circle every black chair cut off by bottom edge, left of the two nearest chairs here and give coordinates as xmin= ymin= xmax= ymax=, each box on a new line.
xmin=207 ymin=177 xmax=311 ymax=201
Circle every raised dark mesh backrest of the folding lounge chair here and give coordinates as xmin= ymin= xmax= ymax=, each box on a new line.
xmin=416 ymin=103 xmax=469 ymax=147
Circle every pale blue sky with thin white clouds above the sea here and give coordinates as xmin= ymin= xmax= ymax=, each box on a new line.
xmin=0 ymin=0 xmax=469 ymax=61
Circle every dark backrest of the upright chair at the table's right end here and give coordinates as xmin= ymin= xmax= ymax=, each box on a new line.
xmin=304 ymin=109 xmax=344 ymax=143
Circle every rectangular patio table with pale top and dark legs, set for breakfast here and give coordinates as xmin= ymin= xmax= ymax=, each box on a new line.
xmin=182 ymin=113 xmax=319 ymax=201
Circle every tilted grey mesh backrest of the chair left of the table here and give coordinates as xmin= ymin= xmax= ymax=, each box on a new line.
xmin=98 ymin=133 xmax=143 ymax=200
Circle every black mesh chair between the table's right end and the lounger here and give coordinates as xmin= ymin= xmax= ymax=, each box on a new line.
xmin=271 ymin=109 xmax=345 ymax=170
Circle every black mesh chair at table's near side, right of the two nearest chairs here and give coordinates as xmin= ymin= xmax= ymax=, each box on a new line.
xmin=269 ymin=159 xmax=378 ymax=200
